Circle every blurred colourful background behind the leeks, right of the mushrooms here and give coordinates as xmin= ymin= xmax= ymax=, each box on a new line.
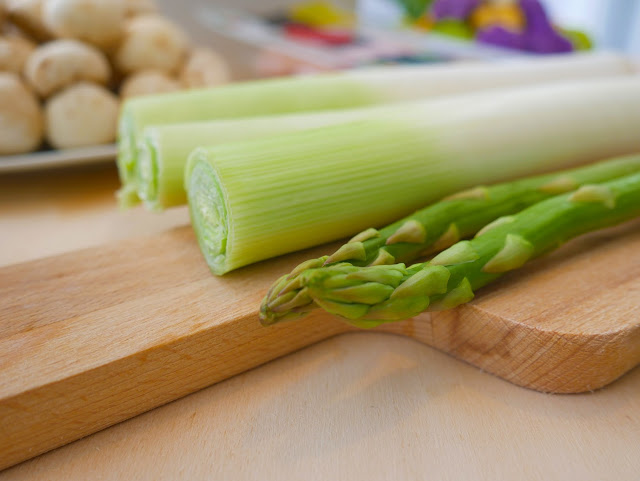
xmin=160 ymin=0 xmax=640 ymax=78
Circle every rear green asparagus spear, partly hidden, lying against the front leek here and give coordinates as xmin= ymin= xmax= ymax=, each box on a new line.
xmin=262 ymin=155 xmax=640 ymax=324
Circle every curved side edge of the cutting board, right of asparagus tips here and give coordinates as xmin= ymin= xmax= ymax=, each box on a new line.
xmin=374 ymin=302 xmax=640 ymax=394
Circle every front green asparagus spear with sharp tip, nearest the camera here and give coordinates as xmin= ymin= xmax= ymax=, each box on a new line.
xmin=262 ymin=168 xmax=640 ymax=327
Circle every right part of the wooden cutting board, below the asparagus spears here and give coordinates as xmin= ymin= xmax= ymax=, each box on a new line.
xmin=380 ymin=221 xmax=640 ymax=393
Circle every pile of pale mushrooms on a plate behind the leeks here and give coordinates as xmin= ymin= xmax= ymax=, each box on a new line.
xmin=0 ymin=0 xmax=229 ymax=155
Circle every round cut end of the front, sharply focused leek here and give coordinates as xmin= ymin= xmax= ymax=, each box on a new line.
xmin=188 ymin=149 xmax=231 ymax=275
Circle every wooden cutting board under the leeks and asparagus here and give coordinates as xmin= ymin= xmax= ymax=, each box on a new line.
xmin=0 ymin=221 xmax=640 ymax=468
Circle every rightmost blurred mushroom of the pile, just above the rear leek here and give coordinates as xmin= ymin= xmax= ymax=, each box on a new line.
xmin=180 ymin=48 xmax=231 ymax=88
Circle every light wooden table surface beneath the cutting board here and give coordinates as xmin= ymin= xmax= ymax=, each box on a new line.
xmin=0 ymin=165 xmax=640 ymax=481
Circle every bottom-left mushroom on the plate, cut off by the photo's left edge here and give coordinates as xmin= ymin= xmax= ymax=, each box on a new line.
xmin=0 ymin=73 xmax=43 ymax=155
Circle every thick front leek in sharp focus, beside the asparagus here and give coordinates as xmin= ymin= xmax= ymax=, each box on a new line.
xmin=186 ymin=78 xmax=640 ymax=274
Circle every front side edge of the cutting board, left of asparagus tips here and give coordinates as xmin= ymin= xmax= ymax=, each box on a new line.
xmin=0 ymin=313 xmax=349 ymax=471
